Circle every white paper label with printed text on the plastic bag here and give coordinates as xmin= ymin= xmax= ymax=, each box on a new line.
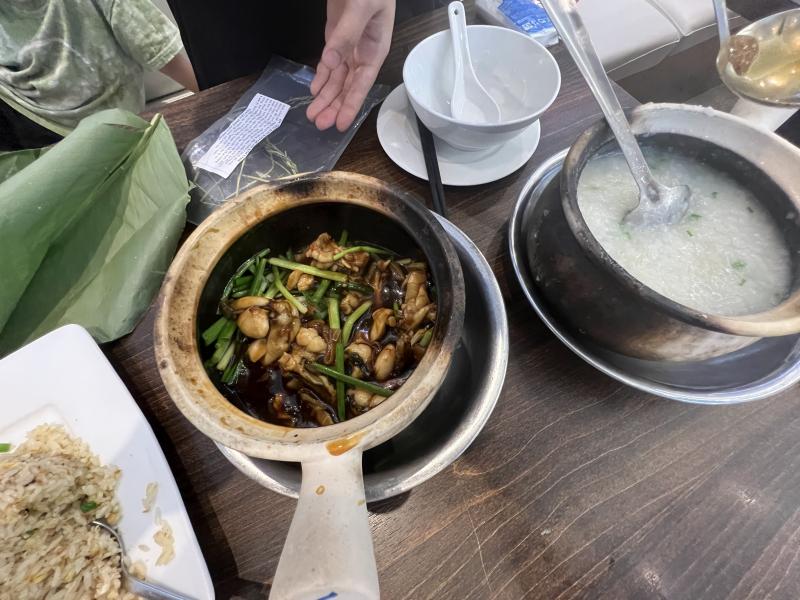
xmin=196 ymin=94 xmax=290 ymax=177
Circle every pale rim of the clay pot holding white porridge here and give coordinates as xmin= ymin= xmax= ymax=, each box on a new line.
xmin=561 ymin=103 xmax=800 ymax=337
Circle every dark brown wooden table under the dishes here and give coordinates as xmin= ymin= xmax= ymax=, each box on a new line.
xmin=119 ymin=5 xmax=800 ymax=600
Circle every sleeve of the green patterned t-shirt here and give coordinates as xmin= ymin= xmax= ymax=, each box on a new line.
xmin=103 ymin=0 xmax=183 ymax=71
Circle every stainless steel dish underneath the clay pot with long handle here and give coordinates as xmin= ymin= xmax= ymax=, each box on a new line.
xmin=217 ymin=219 xmax=508 ymax=502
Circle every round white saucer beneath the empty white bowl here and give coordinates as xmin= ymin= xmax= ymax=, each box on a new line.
xmin=378 ymin=84 xmax=541 ymax=185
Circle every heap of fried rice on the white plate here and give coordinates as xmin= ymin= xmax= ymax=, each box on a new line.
xmin=0 ymin=425 xmax=136 ymax=600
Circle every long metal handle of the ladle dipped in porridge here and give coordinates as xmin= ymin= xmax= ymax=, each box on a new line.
xmin=542 ymin=0 xmax=659 ymax=200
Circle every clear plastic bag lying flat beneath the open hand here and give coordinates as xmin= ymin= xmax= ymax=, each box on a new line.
xmin=182 ymin=57 xmax=389 ymax=224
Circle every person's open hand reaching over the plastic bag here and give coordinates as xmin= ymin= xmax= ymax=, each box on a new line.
xmin=306 ymin=0 xmax=395 ymax=131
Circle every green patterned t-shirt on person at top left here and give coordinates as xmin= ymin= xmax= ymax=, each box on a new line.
xmin=0 ymin=0 xmax=183 ymax=134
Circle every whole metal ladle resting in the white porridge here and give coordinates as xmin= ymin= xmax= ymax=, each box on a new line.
xmin=542 ymin=0 xmax=691 ymax=226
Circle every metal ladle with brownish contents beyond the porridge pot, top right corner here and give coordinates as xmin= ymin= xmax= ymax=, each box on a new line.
xmin=714 ymin=0 xmax=800 ymax=106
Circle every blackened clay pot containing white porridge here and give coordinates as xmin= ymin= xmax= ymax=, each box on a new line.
xmin=527 ymin=104 xmax=800 ymax=361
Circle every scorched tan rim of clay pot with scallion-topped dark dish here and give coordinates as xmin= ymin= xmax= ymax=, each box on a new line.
xmin=155 ymin=172 xmax=464 ymax=460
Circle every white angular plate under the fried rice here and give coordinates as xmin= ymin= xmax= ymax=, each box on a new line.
xmin=0 ymin=325 xmax=214 ymax=600
